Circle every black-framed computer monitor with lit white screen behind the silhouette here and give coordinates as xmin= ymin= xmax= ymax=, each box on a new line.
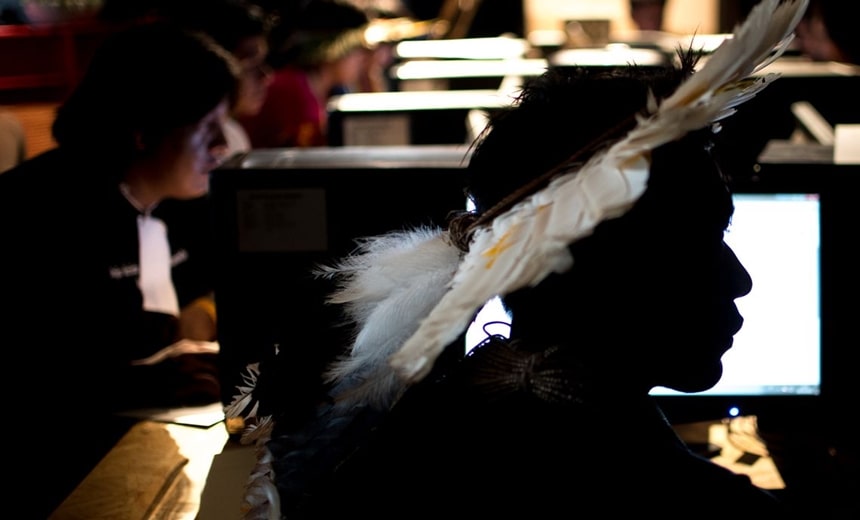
xmin=466 ymin=160 xmax=860 ymax=423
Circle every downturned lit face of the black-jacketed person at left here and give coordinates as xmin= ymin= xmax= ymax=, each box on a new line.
xmin=148 ymin=99 xmax=229 ymax=199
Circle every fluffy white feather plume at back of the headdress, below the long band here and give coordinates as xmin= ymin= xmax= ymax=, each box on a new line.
xmin=317 ymin=227 xmax=461 ymax=408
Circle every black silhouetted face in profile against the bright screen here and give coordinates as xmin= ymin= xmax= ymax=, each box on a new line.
xmin=556 ymin=132 xmax=752 ymax=392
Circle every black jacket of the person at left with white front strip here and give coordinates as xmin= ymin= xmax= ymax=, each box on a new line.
xmin=0 ymin=149 xmax=219 ymax=518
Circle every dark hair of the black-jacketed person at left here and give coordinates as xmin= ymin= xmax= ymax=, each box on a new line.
xmin=52 ymin=22 xmax=238 ymax=160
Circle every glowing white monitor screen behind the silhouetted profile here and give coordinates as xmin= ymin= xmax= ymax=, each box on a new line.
xmin=466 ymin=193 xmax=822 ymax=406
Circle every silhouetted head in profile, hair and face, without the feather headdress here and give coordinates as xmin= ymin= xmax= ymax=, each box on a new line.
xmin=468 ymin=58 xmax=751 ymax=391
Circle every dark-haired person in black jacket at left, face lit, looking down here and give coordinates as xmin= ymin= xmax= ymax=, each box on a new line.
xmin=0 ymin=23 xmax=239 ymax=518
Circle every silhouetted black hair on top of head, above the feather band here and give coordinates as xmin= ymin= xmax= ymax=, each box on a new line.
xmin=467 ymin=52 xmax=695 ymax=219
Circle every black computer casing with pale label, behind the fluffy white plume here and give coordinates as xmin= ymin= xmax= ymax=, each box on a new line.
xmin=210 ymin=146 xmax=468 ymax=420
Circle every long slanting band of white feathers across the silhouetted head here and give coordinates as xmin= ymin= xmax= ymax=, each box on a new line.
xmin=391 ymin=0 xmax=808 ymax=384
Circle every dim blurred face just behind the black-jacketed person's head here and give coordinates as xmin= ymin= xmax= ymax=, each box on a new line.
xmin=233 ymin=36 xmax=272 ymax=116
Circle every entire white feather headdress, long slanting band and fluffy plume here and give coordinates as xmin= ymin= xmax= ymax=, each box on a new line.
xmin=319 ymin=0 xmax=808 ymax=407
